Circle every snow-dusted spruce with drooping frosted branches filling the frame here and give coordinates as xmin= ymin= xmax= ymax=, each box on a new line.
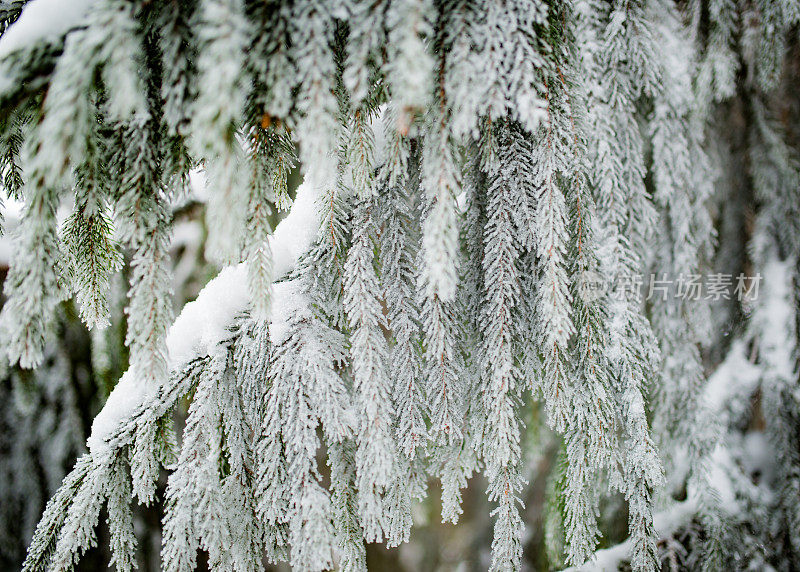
xmin=0 ymin=0 xmax=800 ymax=572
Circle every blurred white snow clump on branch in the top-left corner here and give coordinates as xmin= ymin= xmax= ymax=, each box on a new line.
xmin=0 ymin=0 xmax=95 ymax=59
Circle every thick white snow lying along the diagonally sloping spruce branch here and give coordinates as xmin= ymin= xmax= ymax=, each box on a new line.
xmin=86 ymin=183 xmax=319 ymax=456
